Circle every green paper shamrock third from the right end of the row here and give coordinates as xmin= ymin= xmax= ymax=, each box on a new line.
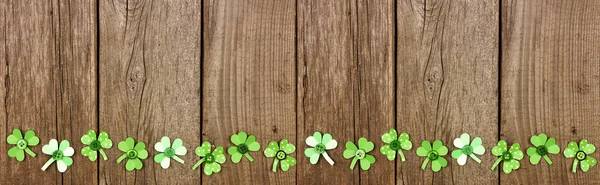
xmin=491 ymin=140 xmax=523 ymax=174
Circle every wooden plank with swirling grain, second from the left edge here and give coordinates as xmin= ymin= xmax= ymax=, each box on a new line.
xmin=99 ymin=0 xmax=201 ymax=184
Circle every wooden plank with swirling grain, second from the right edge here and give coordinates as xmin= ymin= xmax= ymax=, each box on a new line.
xmin=396 ymin=0 xmax=499 ymax=184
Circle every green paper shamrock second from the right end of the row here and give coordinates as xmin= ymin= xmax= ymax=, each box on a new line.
xmin=527 ymin=133 xmax=560 ymax=165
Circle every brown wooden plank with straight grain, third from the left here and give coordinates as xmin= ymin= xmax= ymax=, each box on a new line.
xmin=202 ymin=0 xmax=296 ymax=184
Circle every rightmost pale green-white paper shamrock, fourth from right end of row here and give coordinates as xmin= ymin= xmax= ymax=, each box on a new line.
xmin=452 ymin=133 xmax=485 ymax=166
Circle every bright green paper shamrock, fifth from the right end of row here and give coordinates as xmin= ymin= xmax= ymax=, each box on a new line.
xmin=417 ymin=140 xmax=448 ymax=172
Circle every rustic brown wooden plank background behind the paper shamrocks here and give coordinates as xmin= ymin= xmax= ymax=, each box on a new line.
xmin=0 ymin=0 xmax=600 ymax=185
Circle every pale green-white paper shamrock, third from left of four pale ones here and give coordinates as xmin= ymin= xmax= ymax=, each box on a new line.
xmin=304 ymin=132 xmax=337 ymax=165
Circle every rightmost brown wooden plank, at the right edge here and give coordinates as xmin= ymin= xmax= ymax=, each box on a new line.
xmin=501 ymin=0 xmax=600 ymax=184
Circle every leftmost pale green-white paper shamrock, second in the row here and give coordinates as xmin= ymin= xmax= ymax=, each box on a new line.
xmin=42 ymin=139 xmax=75 ymax=173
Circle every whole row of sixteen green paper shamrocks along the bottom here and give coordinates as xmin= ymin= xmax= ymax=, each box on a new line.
xmin=6 ymin=129 xmax=597 ymax=175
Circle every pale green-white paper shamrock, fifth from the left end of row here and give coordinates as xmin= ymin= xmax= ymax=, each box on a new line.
xmin=154 ymin=136 xmax=187 ymax=169
